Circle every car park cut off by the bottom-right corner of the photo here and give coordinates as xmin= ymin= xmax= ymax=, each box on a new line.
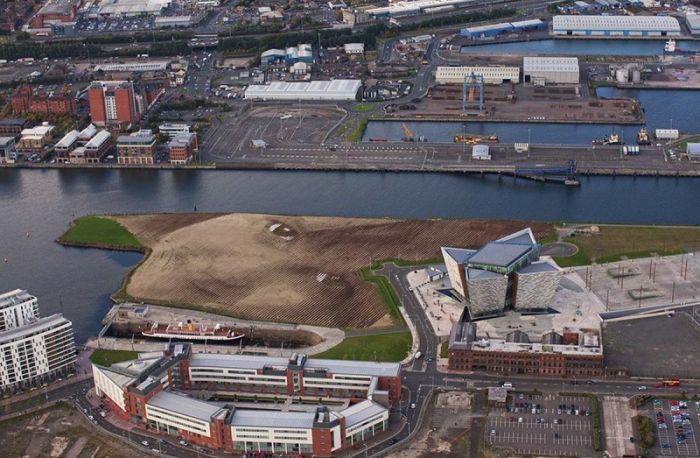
xmin=641 ymin=399 xmax=700 ymax=457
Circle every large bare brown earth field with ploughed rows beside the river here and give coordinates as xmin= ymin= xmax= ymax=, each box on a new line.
xmin=117 ymin=214 xmax=553 ymax=328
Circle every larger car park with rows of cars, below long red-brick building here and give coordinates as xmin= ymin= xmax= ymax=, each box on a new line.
xmin=485 ymin=393 xmax=595 ymax=456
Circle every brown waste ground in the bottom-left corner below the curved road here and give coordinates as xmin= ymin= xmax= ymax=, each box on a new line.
xmin=0 ymin=406 xmax=140 ymax=458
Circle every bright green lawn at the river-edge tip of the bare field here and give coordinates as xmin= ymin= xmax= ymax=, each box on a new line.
xmin=60 ymin=216 xmax=143 ymax=249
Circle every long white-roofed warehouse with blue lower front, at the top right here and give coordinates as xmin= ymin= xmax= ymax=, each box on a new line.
xmin=552 ymin=15 xmax=681 ymax=37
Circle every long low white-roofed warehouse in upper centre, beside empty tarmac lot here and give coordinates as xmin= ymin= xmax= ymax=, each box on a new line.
xmin=245 ymin=80 xmax=362 ymax=101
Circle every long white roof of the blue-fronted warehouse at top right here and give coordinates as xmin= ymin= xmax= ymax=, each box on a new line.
xmin=552 ymin=15 xmax=681 ymax=32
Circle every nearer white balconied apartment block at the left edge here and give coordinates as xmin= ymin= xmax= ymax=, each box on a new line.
xmin=0 ymin=314 xmax=76 ymax=391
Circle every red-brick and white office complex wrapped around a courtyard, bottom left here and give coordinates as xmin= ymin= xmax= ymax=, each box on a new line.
xmin=93 ymin=344 xmax=401 ymax=456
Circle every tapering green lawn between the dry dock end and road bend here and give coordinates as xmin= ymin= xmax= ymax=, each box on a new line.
xmin=314 ymin=331 xmax=413 ymax=362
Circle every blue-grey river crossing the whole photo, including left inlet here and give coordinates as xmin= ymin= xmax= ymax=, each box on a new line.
xmin=0 ymin=170 xmax=700 ymax=341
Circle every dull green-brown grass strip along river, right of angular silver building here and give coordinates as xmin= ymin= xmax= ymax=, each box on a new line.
xmin=555 ymin=226 xmax=700 ymax=267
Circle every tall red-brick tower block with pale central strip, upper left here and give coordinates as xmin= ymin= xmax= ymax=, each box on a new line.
xmin=88 ymin=81 xmax=143 ymax=127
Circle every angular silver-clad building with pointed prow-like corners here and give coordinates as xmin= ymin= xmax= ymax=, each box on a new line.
xmin=442 ymin=228 xmax=562 ymax=318
